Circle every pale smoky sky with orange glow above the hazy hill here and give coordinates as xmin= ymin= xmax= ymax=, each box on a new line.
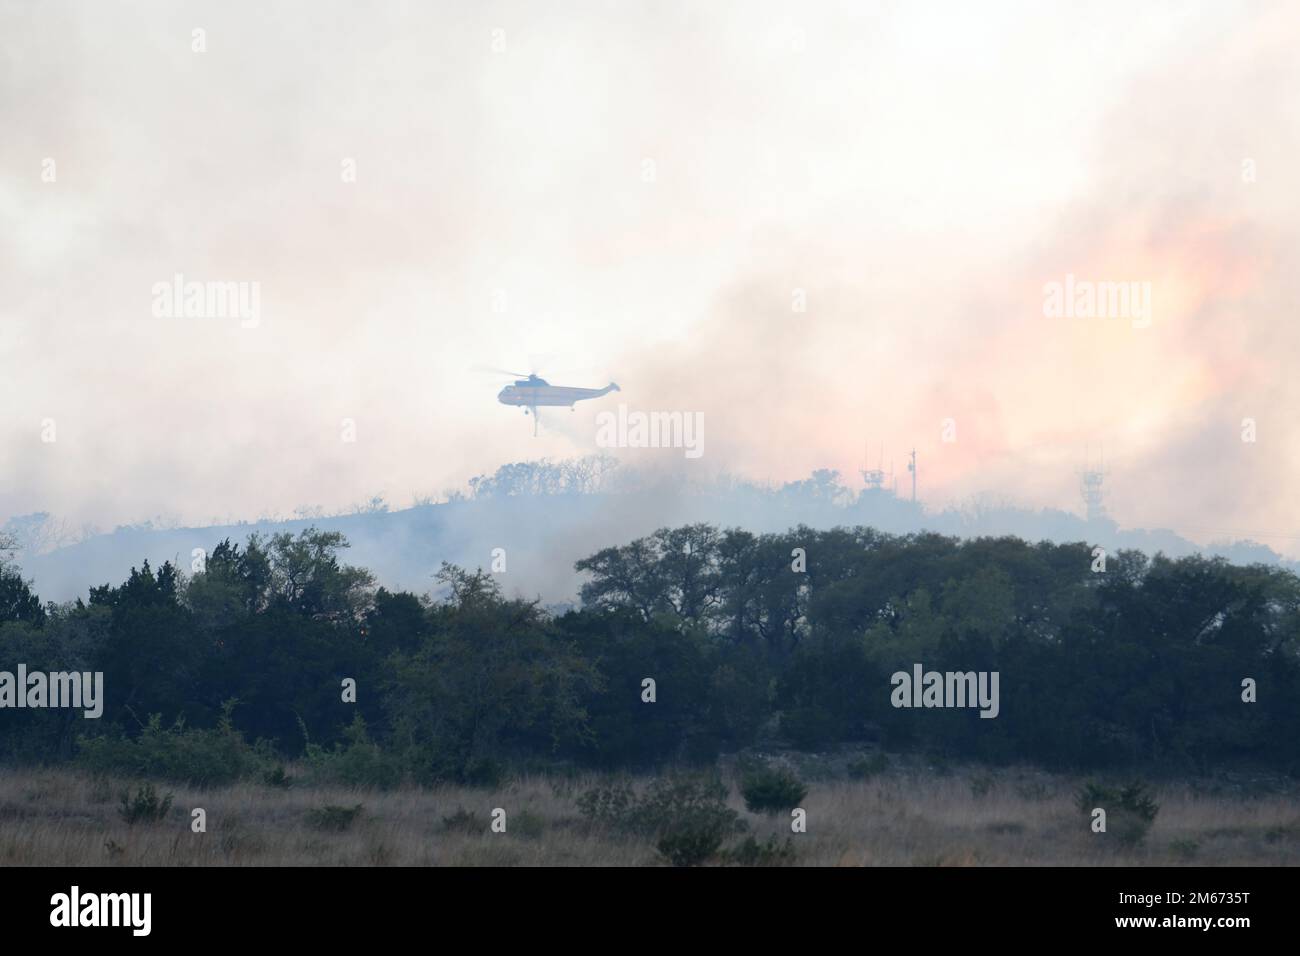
xmin=0 ymin=0 xmax=1300 ymax=554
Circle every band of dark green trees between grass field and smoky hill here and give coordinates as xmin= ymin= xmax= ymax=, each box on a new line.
xmin=0 ymin=524 xmax=1300 ymax=782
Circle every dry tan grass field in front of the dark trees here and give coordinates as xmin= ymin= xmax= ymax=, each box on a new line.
xmin=0 ymin=766 xmax=1300 ymax=866
